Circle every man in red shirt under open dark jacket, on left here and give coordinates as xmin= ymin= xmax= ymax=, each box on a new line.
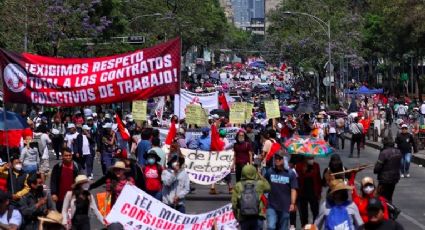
xmin=50 ymin=148 xmax=79 ymax=210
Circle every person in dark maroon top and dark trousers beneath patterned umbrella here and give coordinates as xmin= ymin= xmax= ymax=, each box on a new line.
xmin=295 ymin=157 xmax=322 ymax=227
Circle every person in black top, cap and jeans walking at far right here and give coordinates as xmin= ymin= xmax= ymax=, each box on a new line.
xmin=395 ymin=124 xmax=418 ymax=178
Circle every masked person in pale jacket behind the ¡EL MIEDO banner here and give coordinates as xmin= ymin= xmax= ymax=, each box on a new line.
xmin=161 ymin=155 xmax=190 ymax=213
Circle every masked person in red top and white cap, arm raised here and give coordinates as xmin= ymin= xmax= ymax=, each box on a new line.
xmin=348 ymin=171 xmax=389 ymax=223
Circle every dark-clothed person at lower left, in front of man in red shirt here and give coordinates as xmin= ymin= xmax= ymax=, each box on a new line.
xmin=19 ymin=174 xmax=56 ymax=230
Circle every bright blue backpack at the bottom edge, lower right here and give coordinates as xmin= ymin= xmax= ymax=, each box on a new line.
xmin=325 ymin=202 xmax=353 ymax=230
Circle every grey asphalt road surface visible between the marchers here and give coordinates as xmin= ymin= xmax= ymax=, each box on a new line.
xmin=51 ymin=144 xmax=425 ymax=230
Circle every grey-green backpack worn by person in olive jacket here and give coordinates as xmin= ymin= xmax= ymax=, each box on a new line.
xmin=239 ymin=182 xmax=260 ymax=216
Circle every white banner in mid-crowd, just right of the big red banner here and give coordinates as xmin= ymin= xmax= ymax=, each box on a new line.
xmin=174 ymin=89 xmax=218 ymax=119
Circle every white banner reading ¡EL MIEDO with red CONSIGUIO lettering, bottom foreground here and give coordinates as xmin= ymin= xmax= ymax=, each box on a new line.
xmin=106 ymin=185 xmax=238 ymax=230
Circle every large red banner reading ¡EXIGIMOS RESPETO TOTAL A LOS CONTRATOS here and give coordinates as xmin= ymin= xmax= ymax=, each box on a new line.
xmin=0 ymin=39 xmax=181 ymax=106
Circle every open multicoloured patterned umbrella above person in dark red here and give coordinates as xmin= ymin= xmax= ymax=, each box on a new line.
xmin=284 ymin=136 xmax=334 ymax=157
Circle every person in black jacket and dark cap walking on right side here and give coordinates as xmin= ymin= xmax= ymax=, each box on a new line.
xmin=373 ymin=137 xmax=402 ymax=203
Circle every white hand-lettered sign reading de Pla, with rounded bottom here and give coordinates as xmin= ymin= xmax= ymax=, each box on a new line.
xmin=180 ymin=148 xmax=234 ymax=185
